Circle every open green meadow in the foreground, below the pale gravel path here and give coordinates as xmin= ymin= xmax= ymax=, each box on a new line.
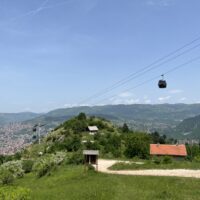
xmin=3 ymin=166 xmax=200 ymax=200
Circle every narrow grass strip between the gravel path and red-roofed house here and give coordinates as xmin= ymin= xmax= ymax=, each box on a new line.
xmin=110 ymin=161 xmax=200 ymax=170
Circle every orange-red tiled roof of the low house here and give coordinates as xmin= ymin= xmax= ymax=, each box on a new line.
xmin=150 ymin=144 xmax=187 ymax=156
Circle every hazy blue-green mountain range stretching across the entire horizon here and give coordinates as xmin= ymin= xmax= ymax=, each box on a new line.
xmin=0 ymin=104 xmax=200 ymax=141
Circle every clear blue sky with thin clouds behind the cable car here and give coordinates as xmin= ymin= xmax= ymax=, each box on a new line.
xmin=0 ymin=0 xmax=200 ymax=112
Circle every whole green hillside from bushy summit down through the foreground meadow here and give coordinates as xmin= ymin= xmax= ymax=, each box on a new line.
xmin=0 ymin=113 xmax=199 ymax=200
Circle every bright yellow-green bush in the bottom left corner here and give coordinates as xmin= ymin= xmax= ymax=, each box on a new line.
xmin=0 ymin=187 xmax=31 ymax=200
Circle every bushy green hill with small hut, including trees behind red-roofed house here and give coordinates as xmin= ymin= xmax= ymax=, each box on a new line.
xmin=24 ymin=113 xmax=169 ymax=162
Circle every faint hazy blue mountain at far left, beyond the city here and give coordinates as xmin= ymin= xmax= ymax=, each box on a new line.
xmin=0 ymin=112 xmax=40 ymax=126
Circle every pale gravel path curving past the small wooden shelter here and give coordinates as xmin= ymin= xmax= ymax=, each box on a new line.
xmin=98 ymin=159 xmax=200 ymax=178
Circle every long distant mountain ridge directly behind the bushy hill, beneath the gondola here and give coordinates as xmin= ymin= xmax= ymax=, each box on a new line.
xmin=23 ymin=104 xmax=200 ymax=132
